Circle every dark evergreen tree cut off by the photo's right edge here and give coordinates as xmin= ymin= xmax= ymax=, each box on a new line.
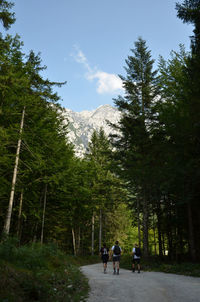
xmin=176 ymin=0 xmax=200 ymax=260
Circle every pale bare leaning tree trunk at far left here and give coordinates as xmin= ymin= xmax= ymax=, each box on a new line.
xmin=3 ymin=107 xmax=25 ymax=236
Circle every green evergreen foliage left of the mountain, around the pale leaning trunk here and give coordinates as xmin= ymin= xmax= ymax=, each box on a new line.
xmin=0 ymin=30 xmax=76 ymax=248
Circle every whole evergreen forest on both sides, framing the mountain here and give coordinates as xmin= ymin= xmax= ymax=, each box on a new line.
xmin=0 ymin=0 xmax=200 ymax=262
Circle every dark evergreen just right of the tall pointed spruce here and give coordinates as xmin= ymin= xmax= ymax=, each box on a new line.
xmin=155 ymin=45 xmax=189 ymax=259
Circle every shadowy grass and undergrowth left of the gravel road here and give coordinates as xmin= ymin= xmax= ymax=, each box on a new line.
xmin=0 ymin=239 xmax=98 ymax=302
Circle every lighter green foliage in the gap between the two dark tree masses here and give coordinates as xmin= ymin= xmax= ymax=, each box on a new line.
xmin=86 ymin=129 xmax=130 ymax=253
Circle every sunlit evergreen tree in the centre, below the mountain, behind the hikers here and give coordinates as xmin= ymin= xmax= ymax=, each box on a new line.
xmin=86 ymin=128 xmax=126 ymax=254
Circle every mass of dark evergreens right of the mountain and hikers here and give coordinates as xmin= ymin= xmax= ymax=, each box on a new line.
xmin=109 ymin=5 xmax=200 ymax=260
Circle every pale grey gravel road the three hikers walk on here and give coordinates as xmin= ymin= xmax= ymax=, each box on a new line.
xmin=81 ymin=262 xmax=200 ymax=302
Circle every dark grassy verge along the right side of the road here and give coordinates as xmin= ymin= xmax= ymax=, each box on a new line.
xmin=120 ymin=254 xmax=200 ymax=277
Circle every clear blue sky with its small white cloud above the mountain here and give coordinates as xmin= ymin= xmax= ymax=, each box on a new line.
xmin=8 ymin=0 xmax=192 ymax=111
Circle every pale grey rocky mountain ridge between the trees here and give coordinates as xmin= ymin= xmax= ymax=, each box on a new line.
xmin=63 ymin=105 xmax=120 ymax=157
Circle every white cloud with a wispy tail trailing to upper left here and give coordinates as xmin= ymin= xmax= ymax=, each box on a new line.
xmin=73 ymin=46 xmax=123 ymax=94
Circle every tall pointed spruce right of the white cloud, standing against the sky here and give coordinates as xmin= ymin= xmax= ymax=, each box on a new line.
xmin=113 ymin=38 xmax=158 ymax=256
